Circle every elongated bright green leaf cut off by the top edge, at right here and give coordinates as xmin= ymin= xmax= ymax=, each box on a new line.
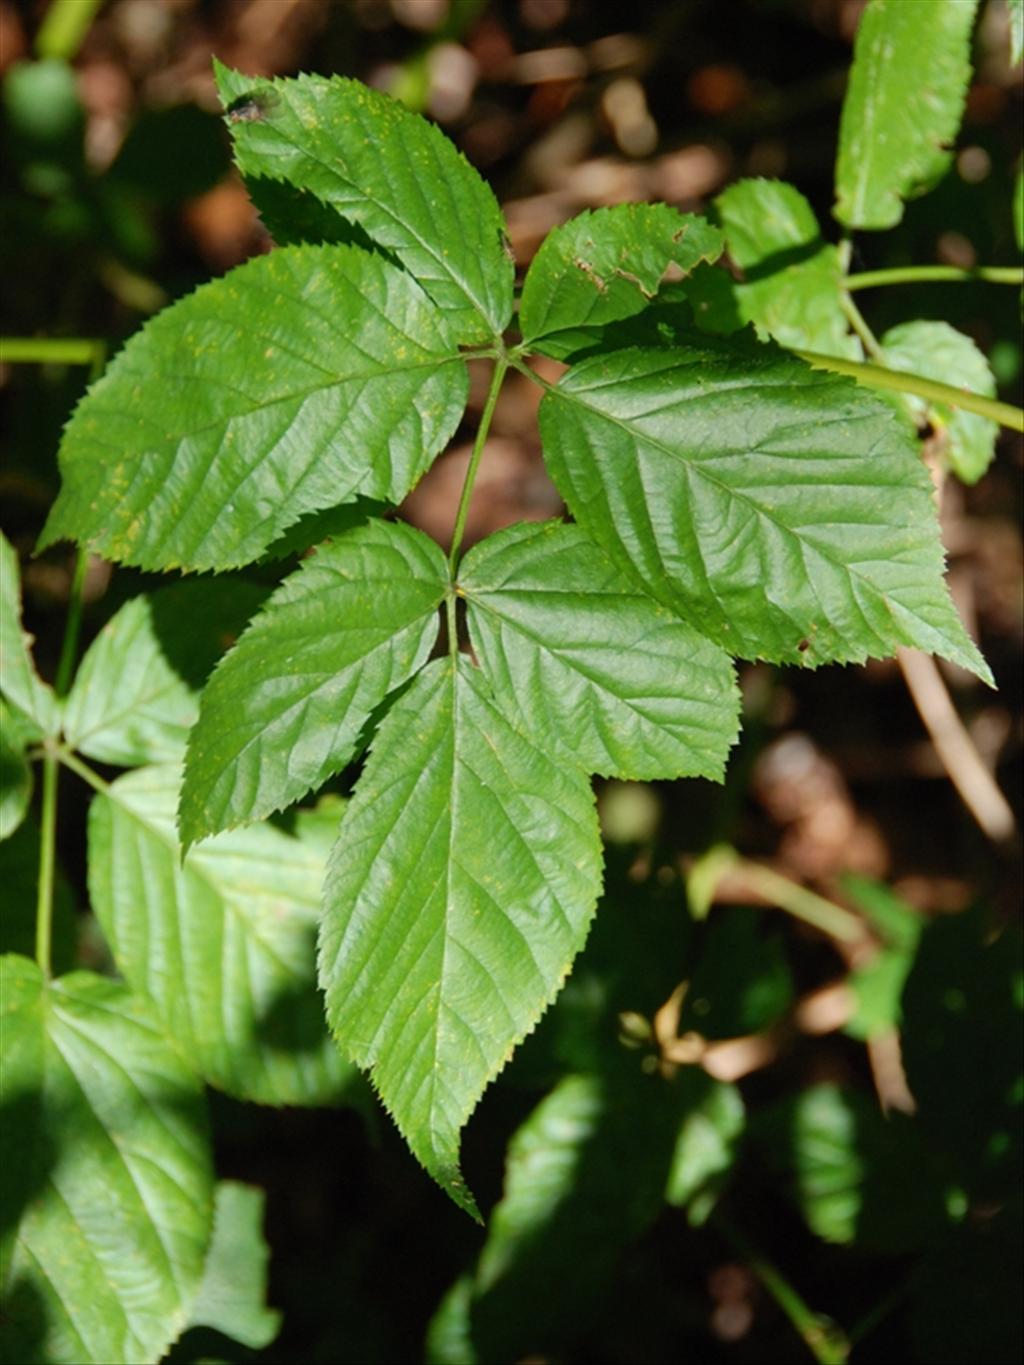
xmin=833 ymin=0 xmax=978 ymax=228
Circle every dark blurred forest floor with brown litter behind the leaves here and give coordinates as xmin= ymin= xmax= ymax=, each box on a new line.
xmin=0 ymin=0 xmax=1024 ymax=1362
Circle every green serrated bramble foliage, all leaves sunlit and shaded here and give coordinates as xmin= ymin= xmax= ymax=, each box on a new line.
xmin=0 ymin=0 xmax=1021 ymax=1361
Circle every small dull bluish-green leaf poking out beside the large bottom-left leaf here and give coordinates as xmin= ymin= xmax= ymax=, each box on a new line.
xmin=182 ymin=1181 xmax=281 ymax=1351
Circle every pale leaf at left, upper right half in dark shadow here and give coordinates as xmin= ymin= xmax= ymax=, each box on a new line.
xmin=64 ymin=579 xmax=266 ymax=767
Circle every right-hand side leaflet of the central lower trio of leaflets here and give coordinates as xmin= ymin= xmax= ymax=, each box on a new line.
xmin=459 ymin=521 xmax=739 ymax=781
